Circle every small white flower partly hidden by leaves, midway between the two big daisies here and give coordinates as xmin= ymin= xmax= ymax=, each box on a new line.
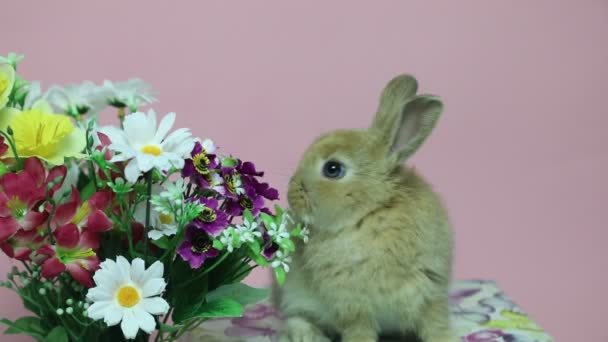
xmin=134 ymin=185 xmax=177 ymax=240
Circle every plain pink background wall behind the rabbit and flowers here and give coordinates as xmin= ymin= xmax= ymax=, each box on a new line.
xmin=0 ymin=0 xmax=608 ymax=341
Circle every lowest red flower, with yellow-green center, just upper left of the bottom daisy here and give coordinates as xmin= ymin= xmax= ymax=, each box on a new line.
xmin=38 ymin=223 xmax=99 ymax=288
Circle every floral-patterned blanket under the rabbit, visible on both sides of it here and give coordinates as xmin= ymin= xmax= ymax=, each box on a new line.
xmin=185 ymin=280 xmax=553 ymax=342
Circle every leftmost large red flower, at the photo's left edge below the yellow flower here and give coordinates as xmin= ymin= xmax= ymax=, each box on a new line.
xmin=0 ymin=158 xmax=66 ymax=241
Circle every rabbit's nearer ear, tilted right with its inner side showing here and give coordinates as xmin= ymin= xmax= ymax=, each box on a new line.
xmin=385 ymin=95 xmax=443 ymax=163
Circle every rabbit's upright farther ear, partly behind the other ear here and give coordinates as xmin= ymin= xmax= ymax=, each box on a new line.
xmin=372 ymin=74 xmax=418 ymax=133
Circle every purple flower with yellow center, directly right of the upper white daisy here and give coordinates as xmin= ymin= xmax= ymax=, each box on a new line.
xmin=182 ymin=140 xmax=219 ymax=188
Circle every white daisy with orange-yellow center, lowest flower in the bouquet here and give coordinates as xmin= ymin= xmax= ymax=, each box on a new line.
xmin=87 ymin=256 xmax=169 ymax=339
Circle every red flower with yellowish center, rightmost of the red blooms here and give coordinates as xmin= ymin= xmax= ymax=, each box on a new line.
xmin=51 ymin=187 xmax=112 ymax=232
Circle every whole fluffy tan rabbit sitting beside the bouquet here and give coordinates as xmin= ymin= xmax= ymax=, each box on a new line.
xmin=273 ymin=74 xmax=456 ymax=342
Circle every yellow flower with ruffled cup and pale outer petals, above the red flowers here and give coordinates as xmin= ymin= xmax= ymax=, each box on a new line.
xmin=0 ymin=100 xmax=86 ymax=165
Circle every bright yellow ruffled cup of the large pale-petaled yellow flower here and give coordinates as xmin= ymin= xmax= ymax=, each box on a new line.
xmin=10 ymin=109 xmax=74 ymax=157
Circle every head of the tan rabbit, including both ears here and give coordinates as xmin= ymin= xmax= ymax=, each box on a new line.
xmin=288 ymin=75 xmax=443 ymax=231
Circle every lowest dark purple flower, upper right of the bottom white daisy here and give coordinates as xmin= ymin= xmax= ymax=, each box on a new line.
xmin=177 ymin=225 xmax=220 ymax=268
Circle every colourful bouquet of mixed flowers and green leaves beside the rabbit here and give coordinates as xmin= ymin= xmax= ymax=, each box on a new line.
xmin=0 ymin=54 xmax=307 ymax=342
